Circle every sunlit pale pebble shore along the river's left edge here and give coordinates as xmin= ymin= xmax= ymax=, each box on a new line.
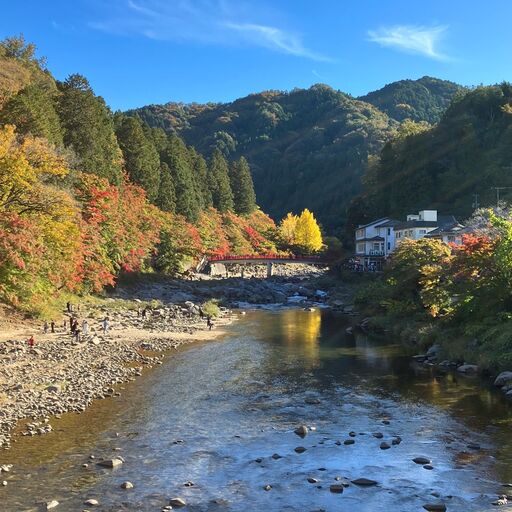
xmin=0 ymin=311 xmax=237 ymax=450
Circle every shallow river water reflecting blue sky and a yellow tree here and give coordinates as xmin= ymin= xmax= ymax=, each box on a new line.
xmin=0 ymin=310 xmax=512 ymax=512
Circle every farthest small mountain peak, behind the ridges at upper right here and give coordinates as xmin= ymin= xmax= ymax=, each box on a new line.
xmin=359 ymin=76 xmax=466 ymax=124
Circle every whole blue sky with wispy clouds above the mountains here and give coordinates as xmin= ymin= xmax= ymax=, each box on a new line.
xmin=0 ymin=0 xmax=512 ymax=109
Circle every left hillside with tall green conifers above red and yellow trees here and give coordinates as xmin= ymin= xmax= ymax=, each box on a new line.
xmin=0 ymin=37 xmax=277 ymax=313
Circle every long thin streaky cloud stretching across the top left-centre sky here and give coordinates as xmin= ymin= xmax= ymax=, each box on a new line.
xmin=89 ymin=0 xmax=330 ymax=61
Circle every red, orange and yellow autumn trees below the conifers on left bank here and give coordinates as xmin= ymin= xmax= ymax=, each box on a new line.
xmin=0 ymin=125 xmax=275 ymax=312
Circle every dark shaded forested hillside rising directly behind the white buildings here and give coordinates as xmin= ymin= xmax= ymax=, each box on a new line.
xmin=351 ymin=83 xmax=512 ymax=227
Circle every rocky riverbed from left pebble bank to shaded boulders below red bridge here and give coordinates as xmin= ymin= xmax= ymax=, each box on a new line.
xmin=0 ymin=266 xmax=345 ymax=448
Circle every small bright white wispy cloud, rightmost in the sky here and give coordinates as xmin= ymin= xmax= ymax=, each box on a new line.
xmin=368 ymin=25 xmax=448 ymax=60
